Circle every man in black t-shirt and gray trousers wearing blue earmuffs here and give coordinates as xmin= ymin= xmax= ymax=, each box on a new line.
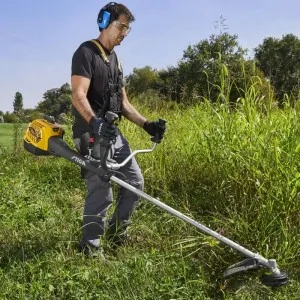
xmin=71 ymin=2 xmax=165 ymax=256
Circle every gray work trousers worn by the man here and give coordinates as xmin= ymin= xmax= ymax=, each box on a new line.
xmin=74 ymin=133 xmax=144 ymax=246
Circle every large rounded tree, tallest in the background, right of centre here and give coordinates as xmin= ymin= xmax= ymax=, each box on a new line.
xmin=179 ymin=33 xmax=247 ymax=102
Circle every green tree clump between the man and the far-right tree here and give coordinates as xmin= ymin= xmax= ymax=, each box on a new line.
xmin=128 ymin=33 xmax=272 ymax=105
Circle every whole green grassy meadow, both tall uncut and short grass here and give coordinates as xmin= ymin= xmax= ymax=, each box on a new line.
xmin=0 ymin=97 xmax=300 ymax=300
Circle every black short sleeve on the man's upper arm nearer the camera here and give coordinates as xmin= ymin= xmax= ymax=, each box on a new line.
xmin=72 ymin=45 xmax=93 ymax=79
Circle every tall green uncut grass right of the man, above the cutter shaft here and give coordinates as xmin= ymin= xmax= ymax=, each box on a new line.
xmin=130 ymin=95 xmax=300 ymax=255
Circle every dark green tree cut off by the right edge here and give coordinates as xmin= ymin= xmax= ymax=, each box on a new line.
xmin=254 ymin=34 xmax=300 ymax=101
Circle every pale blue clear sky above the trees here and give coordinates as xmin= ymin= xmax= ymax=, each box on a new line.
xmin=0 ymin=0 xmax=300 ymax=112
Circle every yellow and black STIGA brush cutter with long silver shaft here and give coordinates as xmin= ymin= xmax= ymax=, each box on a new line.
xmin=24 ymin=112 xmax=288 ymax=287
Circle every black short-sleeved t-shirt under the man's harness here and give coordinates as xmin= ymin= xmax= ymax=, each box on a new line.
xmin=72 ymin=41 xmax=123 ymax=138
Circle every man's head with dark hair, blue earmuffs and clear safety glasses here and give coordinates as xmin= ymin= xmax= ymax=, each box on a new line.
xmin=97 ymin=2 xmax=135 ymax=45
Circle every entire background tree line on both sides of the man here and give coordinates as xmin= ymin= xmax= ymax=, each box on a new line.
xmin=0 ymin=32 xmax=300 ymax=122
